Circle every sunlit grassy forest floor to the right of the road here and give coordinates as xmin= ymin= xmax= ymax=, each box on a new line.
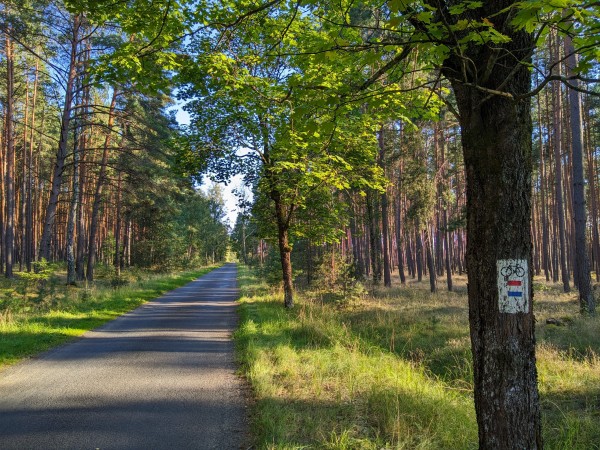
xmin=236 ymin=267 xmax=600 ymax=450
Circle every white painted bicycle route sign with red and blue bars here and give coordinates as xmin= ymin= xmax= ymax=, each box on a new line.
xmin=496 ymin=259 xmax=529 ymax=314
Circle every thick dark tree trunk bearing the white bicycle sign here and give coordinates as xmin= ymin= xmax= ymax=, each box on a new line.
xmin=444 ymin=1 xmax=542 ymax=450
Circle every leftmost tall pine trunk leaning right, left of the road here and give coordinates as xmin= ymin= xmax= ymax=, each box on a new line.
xmin=39 ymin=14 xmax=81 ymax=259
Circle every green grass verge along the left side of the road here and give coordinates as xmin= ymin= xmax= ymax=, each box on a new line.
xmin=0 ymin=266 xmax=216 ymax=369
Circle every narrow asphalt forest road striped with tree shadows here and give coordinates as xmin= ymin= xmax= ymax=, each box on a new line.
xmin=0 ymin=264 xmax=247 ymax=450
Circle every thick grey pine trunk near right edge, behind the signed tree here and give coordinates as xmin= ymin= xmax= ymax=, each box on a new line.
xmin=565 ymin=38 xmax=596 ymax=314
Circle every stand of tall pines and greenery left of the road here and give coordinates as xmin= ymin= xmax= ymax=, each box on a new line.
xmin=0 ymin=2 xmax=227 ymax=283
